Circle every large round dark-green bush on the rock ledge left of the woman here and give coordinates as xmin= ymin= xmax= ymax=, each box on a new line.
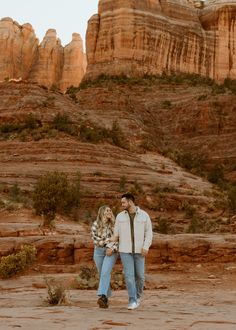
xmin=33 ymin=172 xmax=80 ymax=224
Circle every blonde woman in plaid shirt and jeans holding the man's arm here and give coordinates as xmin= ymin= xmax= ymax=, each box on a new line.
xmin=92 ymin=205 xmax=118 ymax=308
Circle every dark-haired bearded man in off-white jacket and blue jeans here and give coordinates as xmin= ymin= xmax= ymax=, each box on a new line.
xmin=114 ymin=193 xmax=152 ymax=309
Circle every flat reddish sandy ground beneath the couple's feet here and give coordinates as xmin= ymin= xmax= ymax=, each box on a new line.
xmin=0 ymin=265 xmax=236 ymax=330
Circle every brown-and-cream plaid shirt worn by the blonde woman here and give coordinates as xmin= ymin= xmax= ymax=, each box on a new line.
xmin=91 ymin=221 xmax=118 ymax=252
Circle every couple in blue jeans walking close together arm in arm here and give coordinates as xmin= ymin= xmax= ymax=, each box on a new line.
xmin=92 ymin=193 xmax=152 ymax=310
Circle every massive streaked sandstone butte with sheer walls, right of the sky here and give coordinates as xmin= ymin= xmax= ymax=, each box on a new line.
xmin=86 ymin=0 xmax=236 ymax=81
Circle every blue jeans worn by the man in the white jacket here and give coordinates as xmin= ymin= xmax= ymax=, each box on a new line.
xmin=120 ymin=252 xmax=145 ymax=303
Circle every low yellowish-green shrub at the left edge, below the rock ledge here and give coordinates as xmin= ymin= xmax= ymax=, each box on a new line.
xmin=0 ymin=245 xmax=37 ymax=278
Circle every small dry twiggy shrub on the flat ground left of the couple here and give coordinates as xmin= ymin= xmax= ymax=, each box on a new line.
xmin=45 ymin=278 xmax=69 ymax=306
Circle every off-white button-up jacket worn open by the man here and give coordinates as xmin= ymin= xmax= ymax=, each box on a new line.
xmin=114 ymin=207 xmax=152 ymax=253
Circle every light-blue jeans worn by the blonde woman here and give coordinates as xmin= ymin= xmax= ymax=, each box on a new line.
xmin=93 ymin=247 xmax=117 ymax=297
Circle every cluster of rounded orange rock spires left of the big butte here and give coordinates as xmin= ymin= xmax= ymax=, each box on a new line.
xmin=0 ymin=18 xmax=86 ymax=91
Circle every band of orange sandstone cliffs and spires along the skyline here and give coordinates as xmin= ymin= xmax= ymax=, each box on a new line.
xmin=0 ymin=0 xmax=236 ymax=91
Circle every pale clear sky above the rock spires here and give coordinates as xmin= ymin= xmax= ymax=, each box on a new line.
xmin=0 ymin=0 xmax=99 ymax=46
